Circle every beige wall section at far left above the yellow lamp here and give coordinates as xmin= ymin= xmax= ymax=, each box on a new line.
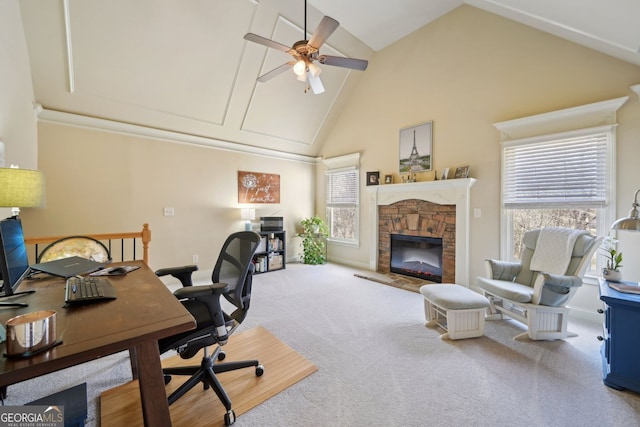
xmin=0 ymin=0 xmax=38 ymax=218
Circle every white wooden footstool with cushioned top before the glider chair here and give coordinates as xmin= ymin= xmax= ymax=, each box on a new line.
xmin=420 ymin=284 xmax=489 ymax=340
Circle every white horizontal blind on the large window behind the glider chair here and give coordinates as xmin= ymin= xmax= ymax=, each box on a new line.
xmin=503 ymin=132 xmax=610 ymax=208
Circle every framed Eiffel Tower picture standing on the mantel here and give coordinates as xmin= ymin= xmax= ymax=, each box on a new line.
xmin=399 ymin=122 xmax=433 ymax=174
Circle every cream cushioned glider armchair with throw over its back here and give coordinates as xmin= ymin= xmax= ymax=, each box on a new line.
xmin=476 ymin=228 xmax=602 ymax=340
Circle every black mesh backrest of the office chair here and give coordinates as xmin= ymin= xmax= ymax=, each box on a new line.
xmin=211 ymin=231 xmax=260 ymax=322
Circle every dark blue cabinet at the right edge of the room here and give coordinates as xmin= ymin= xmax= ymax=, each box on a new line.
xmin=600 ymin=279 xmax=640 ymax=393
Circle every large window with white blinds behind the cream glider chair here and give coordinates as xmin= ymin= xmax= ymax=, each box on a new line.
xmin=502 ymin=127 xmax=614 ymax=267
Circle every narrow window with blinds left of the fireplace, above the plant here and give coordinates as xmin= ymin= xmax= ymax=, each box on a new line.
xmin=324 ymin=155 xmax=360 ymax=244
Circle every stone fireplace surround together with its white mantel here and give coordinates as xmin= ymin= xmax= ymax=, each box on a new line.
xmin=367 ymin=178 xmax=476 ymax=286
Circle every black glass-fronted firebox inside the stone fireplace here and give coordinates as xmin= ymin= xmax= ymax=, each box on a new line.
xmin=390 ymin=234 xmax=442 ymax=283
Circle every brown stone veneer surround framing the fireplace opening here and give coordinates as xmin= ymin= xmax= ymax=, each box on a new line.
xmin=378 ymin=199 xmax=456 ymax=283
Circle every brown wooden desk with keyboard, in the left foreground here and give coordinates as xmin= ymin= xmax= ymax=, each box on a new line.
xmin=0 ymin=261 xmax=195 ymax=427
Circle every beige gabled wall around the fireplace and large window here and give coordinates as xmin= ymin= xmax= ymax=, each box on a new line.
xmin=318 ymin=6 xmax=640 ymax=318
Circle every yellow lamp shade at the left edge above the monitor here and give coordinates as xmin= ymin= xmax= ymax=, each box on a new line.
xmin=0 ymin=168 xmax=44 ymax=208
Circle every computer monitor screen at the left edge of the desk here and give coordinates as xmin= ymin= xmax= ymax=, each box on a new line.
xmin=0 ymin=218 xmax=29 ymax=295
